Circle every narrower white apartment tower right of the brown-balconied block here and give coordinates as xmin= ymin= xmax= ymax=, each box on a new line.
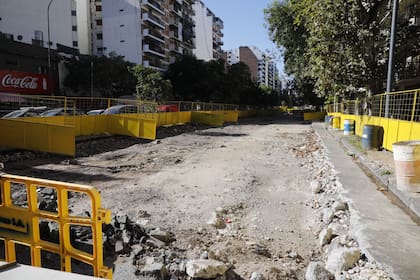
xmin=193 ymin=1 xmax=223 ymax=61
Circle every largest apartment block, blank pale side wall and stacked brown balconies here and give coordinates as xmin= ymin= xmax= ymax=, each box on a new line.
xmin=102 ymin=0 xmax=199 ymax=70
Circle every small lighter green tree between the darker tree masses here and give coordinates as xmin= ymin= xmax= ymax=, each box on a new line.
xmin=132 ymin=65 xmax=172 ymax=101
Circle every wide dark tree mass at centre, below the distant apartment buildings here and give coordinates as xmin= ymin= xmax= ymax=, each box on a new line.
xmin=166 ymin=56 xmax=278 ymax=106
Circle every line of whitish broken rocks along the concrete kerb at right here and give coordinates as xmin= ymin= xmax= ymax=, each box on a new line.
xmin=295 ymin=131 xmax=391 ymax=280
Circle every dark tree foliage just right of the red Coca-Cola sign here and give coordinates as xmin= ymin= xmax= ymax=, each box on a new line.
xmin=64 ymin=53 xmax=136 ymax=97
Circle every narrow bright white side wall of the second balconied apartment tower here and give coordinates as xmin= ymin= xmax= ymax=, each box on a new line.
xmin=193 ymin=1 xmax=213 ymax=61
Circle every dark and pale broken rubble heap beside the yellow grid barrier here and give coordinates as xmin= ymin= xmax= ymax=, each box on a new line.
xmin=103 ymin=215 xmax=241 ymax=279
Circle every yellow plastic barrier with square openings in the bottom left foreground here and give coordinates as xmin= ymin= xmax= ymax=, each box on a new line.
xmin=0 ymin=175 xmax=112 ymax=279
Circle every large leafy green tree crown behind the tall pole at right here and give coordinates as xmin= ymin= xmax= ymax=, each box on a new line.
xmin=265 ymin=0 xmax=420 ymax=100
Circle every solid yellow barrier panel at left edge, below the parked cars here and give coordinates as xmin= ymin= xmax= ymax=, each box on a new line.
xmin=0 ymin=119 xmax=76 ymax=156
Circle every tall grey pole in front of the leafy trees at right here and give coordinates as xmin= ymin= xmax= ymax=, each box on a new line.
xmin=384 ymin=0 xmax=399 ymax=118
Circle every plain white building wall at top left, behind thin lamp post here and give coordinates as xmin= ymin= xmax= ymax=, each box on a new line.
xmin=0 ymin=0 xmax=77 ymax=49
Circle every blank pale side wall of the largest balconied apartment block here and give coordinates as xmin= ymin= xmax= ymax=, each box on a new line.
xmin=102 ymin=0 xmax=142 ymax=64
